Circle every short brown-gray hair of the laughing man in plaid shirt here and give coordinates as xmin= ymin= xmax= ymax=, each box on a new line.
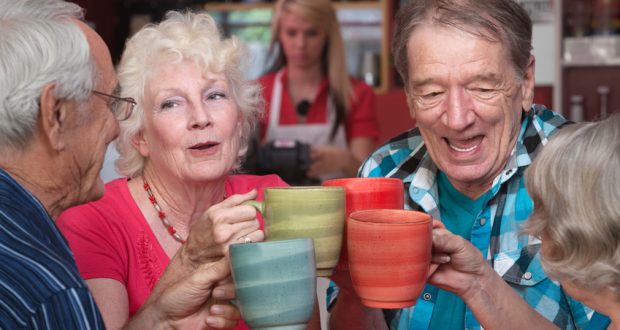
xmin=392 ymin=0 xmax=532 ymax=87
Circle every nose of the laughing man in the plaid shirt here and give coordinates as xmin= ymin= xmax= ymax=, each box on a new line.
xmin=442 ymin=89 xmax=475 ymax=131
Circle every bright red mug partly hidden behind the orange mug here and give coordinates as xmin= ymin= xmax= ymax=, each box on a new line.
xmin=323 ymin=178 xmax=405 ymax=271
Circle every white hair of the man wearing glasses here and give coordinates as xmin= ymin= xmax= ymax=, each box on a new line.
xmin=0 ymin=0 xmax=96 ymax=152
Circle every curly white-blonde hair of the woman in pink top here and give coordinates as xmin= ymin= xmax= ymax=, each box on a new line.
xmin=116 ymin=11 xmax=263 ymax=177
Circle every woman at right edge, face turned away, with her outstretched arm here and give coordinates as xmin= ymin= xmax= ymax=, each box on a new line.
xmin=429 ymin=115 xmax=620 ymax=329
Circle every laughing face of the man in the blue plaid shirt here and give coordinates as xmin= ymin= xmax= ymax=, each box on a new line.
xmin=406 ymin=23 xmax=534 ymax=198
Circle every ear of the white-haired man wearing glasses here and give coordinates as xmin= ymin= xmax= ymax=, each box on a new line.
xmin=39 ymin=83 xmax=69 ymax=150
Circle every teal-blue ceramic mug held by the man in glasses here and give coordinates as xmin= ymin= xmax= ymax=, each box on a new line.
xmin=229 ymin=238 xmax=316 ymax=330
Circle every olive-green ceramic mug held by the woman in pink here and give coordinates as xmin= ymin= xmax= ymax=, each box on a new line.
xmin=245 ymin=186 xmax=345 ymax=276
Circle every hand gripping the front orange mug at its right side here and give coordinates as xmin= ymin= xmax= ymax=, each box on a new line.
xmin=428 ymin=229 xmax=493 ymax=297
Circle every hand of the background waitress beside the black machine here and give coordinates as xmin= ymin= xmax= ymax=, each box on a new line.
xmin=307 ymin=145 xmax=352 ymax=178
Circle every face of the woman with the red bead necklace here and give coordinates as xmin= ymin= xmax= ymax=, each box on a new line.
xmin=134 ymin=61 xmax=241 ymax=181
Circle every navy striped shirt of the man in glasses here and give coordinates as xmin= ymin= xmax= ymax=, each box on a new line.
xmin=0 ymin=169 xmax=104 ymax=329
